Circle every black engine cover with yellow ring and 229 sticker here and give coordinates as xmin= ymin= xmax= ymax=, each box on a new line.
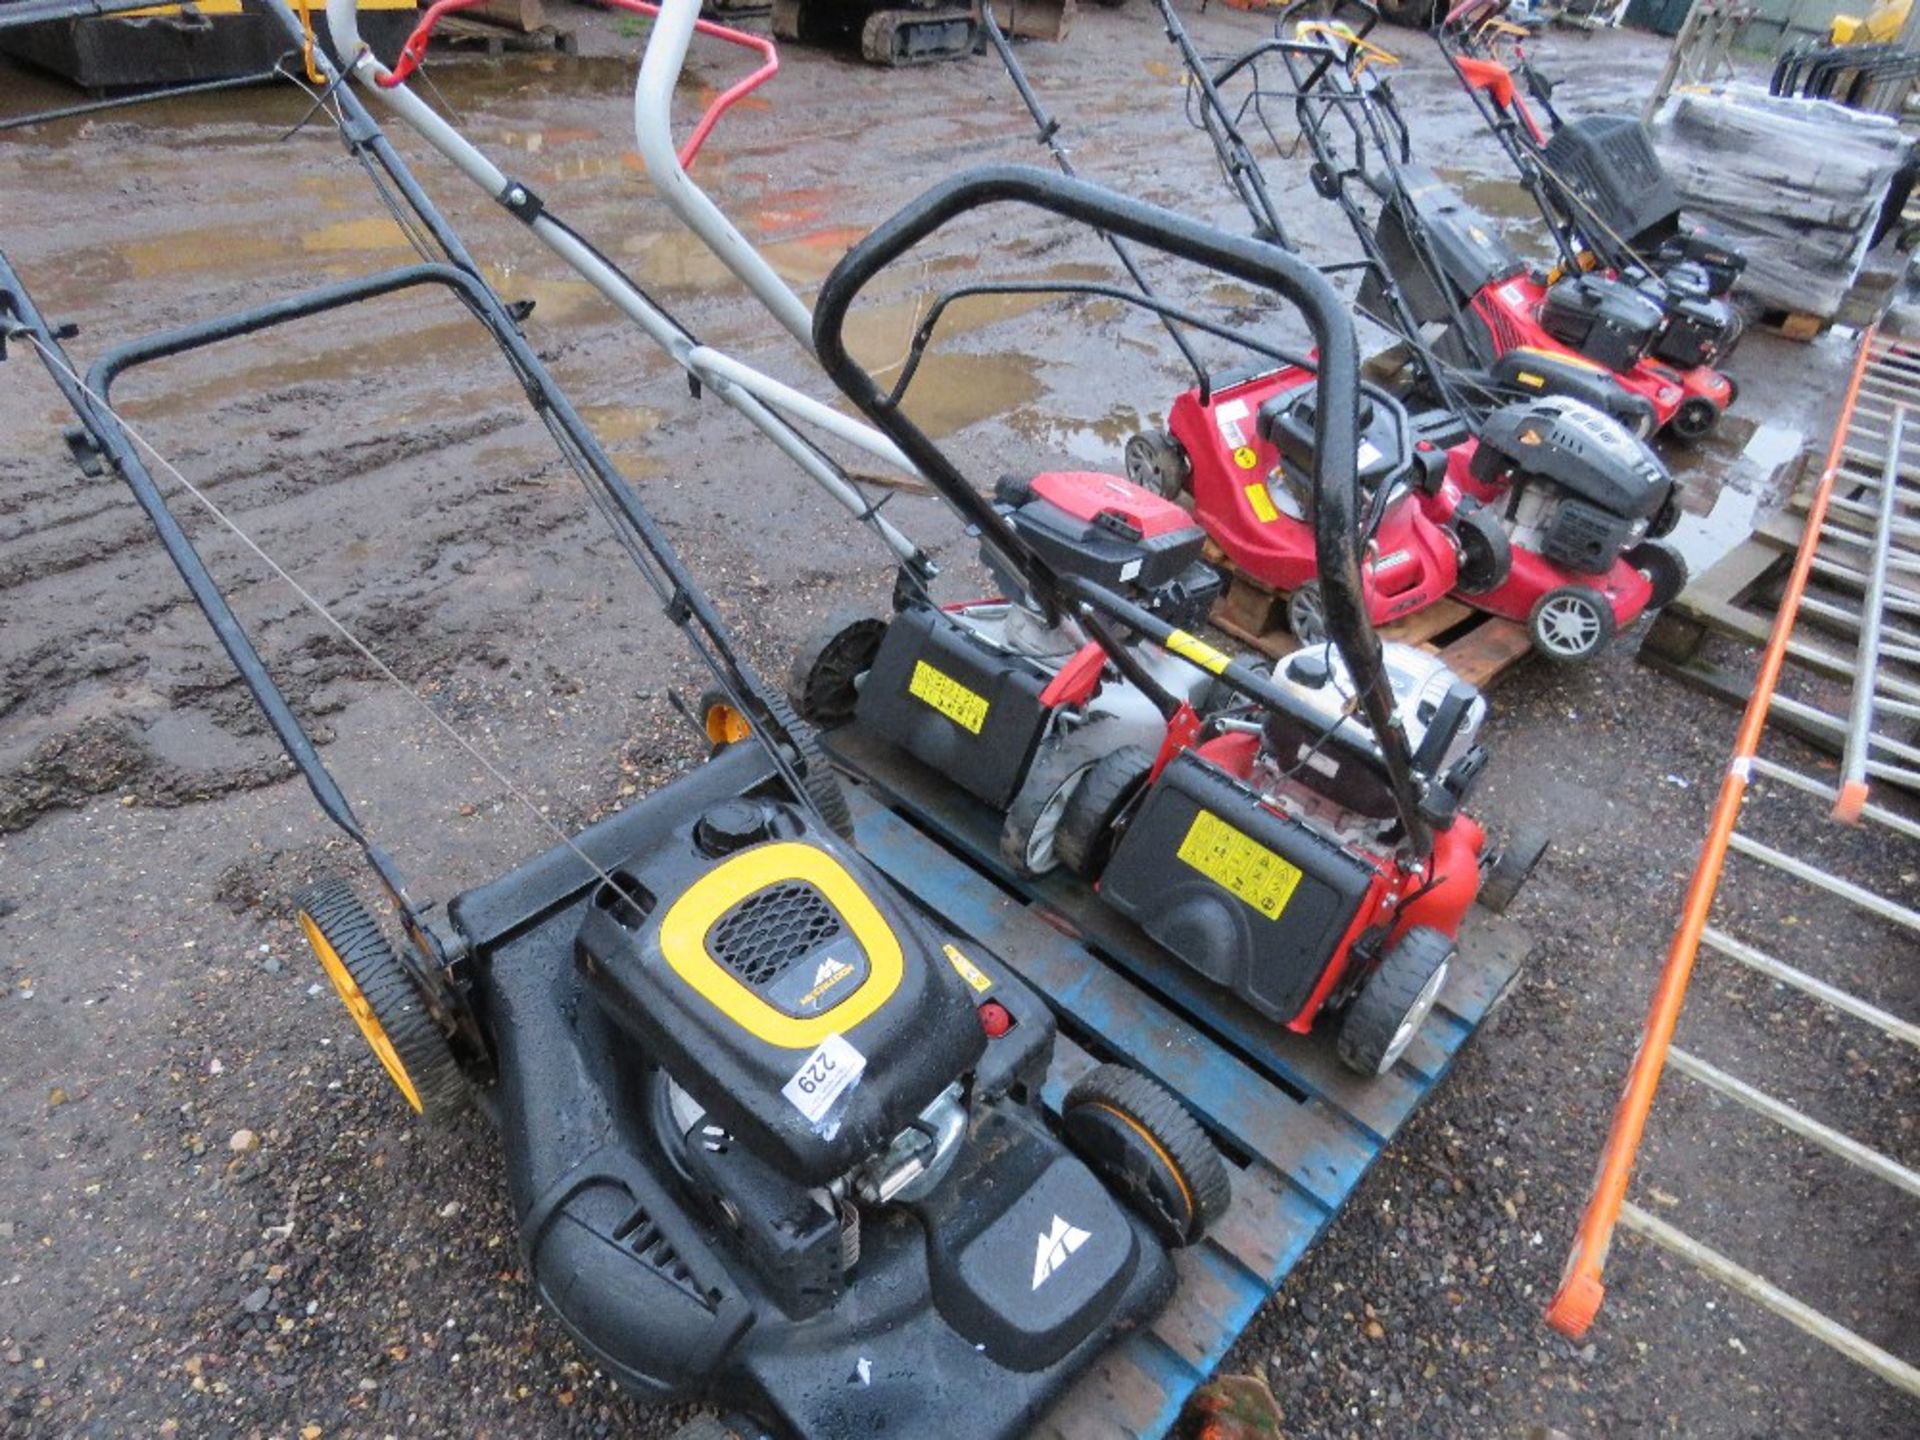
xmin=576 ymin=833 xmax=985 ymax=1185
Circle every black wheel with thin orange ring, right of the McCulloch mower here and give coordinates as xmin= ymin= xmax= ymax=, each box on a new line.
xmin=1060 ymin=1066 xmax=1233 ymax=1246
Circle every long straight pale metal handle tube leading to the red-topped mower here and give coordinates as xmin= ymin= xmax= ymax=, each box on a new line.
xmin=326 ymin=0 xmax=933 ymax=574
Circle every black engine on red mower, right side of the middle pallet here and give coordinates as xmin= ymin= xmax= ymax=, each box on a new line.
xmin=1471 ymin=396 xmax=1680 ymax=574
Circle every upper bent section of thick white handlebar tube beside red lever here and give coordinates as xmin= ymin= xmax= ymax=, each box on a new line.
xmin=634 ymin=0 xmax=814 ymax=355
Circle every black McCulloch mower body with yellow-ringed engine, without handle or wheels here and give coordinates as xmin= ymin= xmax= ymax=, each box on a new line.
xmin=453 ymin=743 xmax=1190 ymax=1436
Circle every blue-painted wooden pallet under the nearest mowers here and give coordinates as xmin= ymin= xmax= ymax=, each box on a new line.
xmin=828 ymin=728 xmax=1526 ymax=1440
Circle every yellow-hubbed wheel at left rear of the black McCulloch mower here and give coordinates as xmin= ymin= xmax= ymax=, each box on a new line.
xmin=296 ymin=876 xmax=467 ymax=1119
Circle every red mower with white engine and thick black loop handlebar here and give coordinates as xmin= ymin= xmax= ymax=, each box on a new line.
xmin=814 ymin=169 xmax=1542 ymax=1075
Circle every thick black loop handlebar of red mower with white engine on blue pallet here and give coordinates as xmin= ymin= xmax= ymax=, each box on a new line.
xmin=814 ymin=165 xmax=1430 ymax=849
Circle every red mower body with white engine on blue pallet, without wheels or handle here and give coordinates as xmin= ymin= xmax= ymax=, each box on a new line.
xmin=1100 ymin=643 xmax=1486 ymax=1031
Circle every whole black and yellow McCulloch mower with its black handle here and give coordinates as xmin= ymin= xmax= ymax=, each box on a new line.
xmin=0 ymin=0 xmax=1229 ymax=1436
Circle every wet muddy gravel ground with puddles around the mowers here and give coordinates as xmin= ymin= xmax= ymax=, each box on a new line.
xmin=0 ymin=0 xmax=1920 ymax=1440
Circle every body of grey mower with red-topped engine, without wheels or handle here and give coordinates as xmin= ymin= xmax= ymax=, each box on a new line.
xmin=856 ymin=472 xmax=1219 ymax=812
